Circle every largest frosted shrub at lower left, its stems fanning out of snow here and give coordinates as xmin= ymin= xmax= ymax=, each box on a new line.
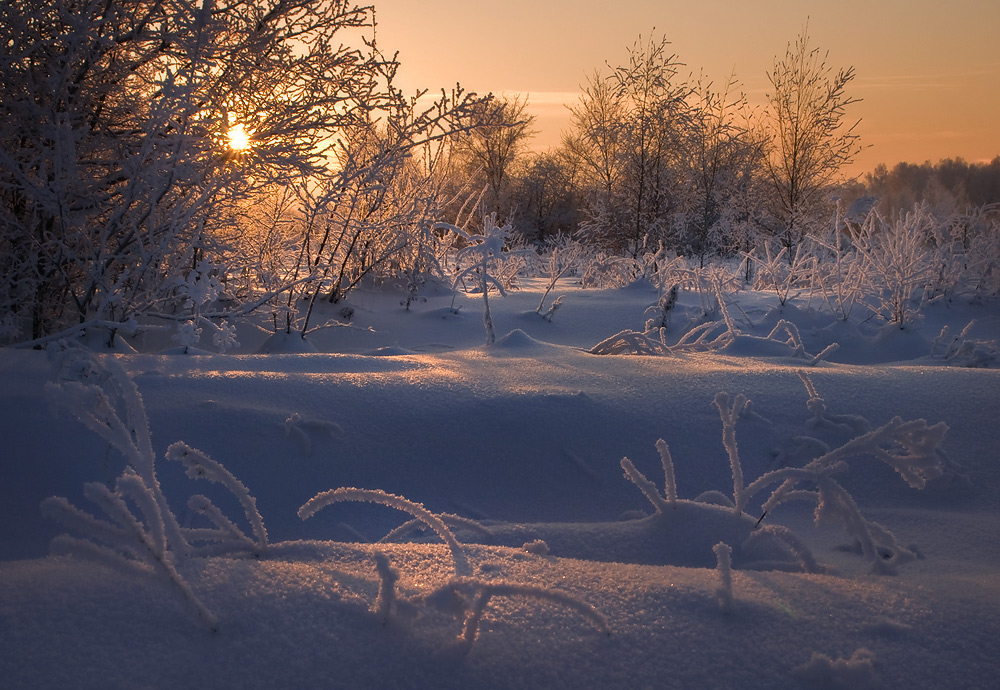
xmin=42 ymin=348 xmax=267 ymax=630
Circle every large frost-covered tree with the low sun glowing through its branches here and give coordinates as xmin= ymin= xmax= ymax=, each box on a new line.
xmin=0 ymin=0 xmax=484 ymax=342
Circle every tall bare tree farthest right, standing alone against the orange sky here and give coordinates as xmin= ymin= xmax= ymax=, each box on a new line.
xmin=765 ymin=26 xmax=862 ymax=257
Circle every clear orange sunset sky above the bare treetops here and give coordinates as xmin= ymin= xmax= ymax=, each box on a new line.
xmin=374 ymin=0 xmax=1000 ymax=173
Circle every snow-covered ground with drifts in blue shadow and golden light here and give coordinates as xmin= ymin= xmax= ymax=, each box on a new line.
xmin=0 ymin=281 xmax=1000 ymax=690
